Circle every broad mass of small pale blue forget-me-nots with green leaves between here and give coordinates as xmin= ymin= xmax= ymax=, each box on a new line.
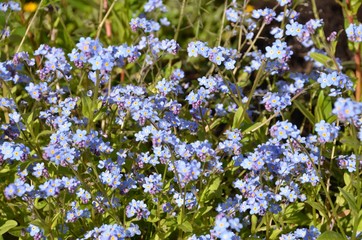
xmin=0 ymin=0 xmax=362 ymax=240
